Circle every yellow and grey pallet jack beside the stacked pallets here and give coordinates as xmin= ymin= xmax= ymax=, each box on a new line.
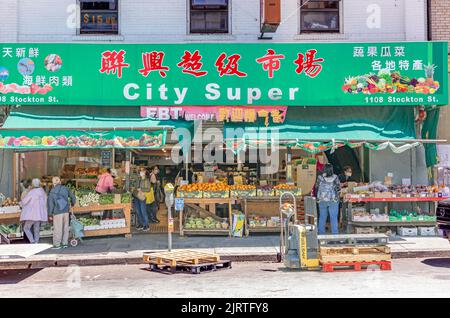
xmin=277 ymin=192 xmax=321 ymax=270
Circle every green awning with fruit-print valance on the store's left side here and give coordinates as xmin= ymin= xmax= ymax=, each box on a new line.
xmin=0 ymin=106 xmax=192 ymax=149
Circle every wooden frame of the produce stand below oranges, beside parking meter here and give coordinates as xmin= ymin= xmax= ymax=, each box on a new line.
xmin=179 ymin=198 xmax=236 ymax=236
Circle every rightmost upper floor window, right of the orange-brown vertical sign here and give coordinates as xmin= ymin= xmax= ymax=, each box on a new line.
xmin=300 ymin=0 xmax=340 ymax=32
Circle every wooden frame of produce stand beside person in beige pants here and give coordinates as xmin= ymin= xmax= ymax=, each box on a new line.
xmin=71 ymin=203 xmax=131 ymax=238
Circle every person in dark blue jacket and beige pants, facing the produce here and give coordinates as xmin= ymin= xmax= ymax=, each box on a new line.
xmin=47 ymin=177 xmax=76 ymax=249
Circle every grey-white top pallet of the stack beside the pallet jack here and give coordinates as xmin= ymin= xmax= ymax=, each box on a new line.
xmin=319 ymin=234 xmax=389 ymax=246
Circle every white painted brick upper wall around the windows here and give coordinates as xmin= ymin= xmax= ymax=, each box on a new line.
xmin=0 ymin=0 xmax=428 ymax=43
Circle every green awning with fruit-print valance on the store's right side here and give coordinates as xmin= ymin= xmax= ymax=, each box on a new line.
xmin=225 ymin=107 xmax=420 ymax=153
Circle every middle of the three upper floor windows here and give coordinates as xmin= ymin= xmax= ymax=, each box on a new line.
xmin=190 ymin=0 xmax=229 ymax=33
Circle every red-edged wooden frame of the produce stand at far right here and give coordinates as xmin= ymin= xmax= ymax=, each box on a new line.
xmin=344 ymin=197 xmax=445 ymax=233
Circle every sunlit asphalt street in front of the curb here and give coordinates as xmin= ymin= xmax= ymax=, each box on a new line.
xmin=0 ymin=258 xmax=450 ymax=298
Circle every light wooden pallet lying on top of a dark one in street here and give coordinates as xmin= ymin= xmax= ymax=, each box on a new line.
xmin=144 ymin=250 xmax=220 ymax=267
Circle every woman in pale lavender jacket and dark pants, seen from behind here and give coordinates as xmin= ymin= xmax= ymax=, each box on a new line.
xmin=20 ymin=179 xmax=48 ymax=244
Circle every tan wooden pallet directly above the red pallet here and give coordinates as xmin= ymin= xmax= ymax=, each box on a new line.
xmin=320 ymin=246 xmax=391 ymax=263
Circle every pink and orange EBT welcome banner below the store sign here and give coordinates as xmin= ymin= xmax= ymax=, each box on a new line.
xmin=141 ymin=106 xmax=287 ymax=126
